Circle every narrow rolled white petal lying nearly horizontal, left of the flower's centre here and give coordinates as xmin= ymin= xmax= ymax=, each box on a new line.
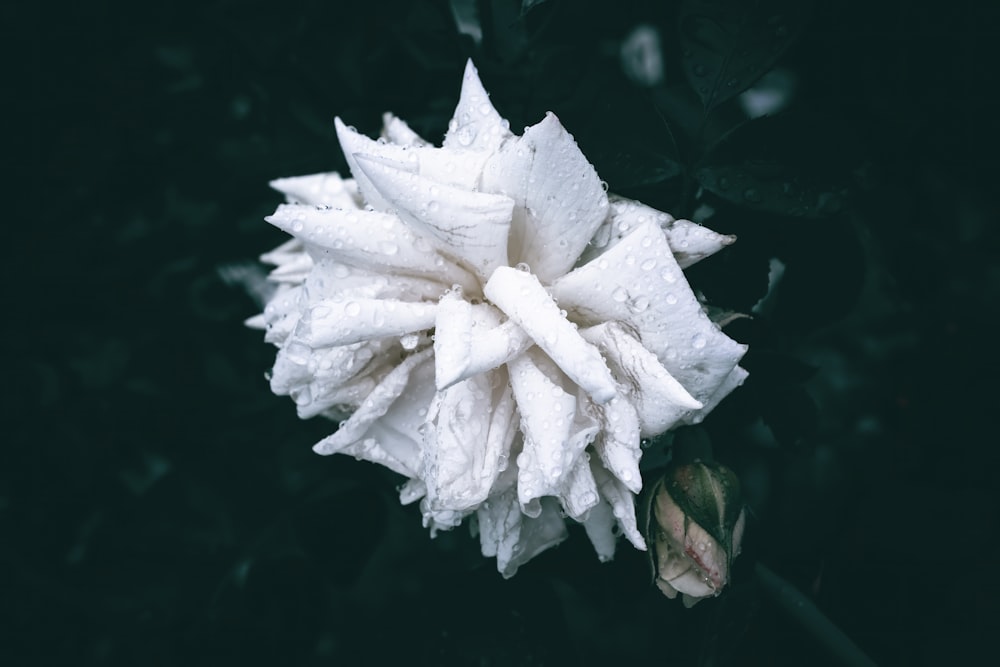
xmin=295 ymin=298 xmax=437 ymax=347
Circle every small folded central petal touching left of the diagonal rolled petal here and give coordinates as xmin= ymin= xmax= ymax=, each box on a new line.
xmin=434 ymin=290 xmax=533 ymax=391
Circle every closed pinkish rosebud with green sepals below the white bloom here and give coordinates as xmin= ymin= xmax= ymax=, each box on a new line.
xmin=646 ymin=461 xmax=746 ymax=607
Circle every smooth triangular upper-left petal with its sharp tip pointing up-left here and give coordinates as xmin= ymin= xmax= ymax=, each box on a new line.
xmin=355 ymin=155 xmax=514 ymax=278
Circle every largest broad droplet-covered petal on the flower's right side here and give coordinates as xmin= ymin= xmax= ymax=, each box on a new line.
xmin=550 ymin=220 xmax=746 ymax=403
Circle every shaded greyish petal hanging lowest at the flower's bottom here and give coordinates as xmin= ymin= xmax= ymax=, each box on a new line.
xmin=477 ymin=489 xmax=569 ymax=579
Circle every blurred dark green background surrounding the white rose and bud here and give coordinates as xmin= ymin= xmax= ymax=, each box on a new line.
xmin=7 ymin=0 xmax=1000 ymax=666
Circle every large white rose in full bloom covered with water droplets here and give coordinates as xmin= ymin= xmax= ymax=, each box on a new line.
xmin=251 ymin=62 xmax=746 ymax=576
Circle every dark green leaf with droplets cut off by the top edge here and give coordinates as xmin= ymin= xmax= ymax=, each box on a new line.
xmin=679 ymin=0 xmax=809 ymax=111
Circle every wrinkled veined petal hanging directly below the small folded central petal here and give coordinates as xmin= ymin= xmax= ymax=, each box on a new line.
xmin=422 ymin=371 xmax=517 ymax=510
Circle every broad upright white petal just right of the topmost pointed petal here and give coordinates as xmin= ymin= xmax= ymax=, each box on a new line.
xmin=482 ymin=113 xmax=608 ymax=283
